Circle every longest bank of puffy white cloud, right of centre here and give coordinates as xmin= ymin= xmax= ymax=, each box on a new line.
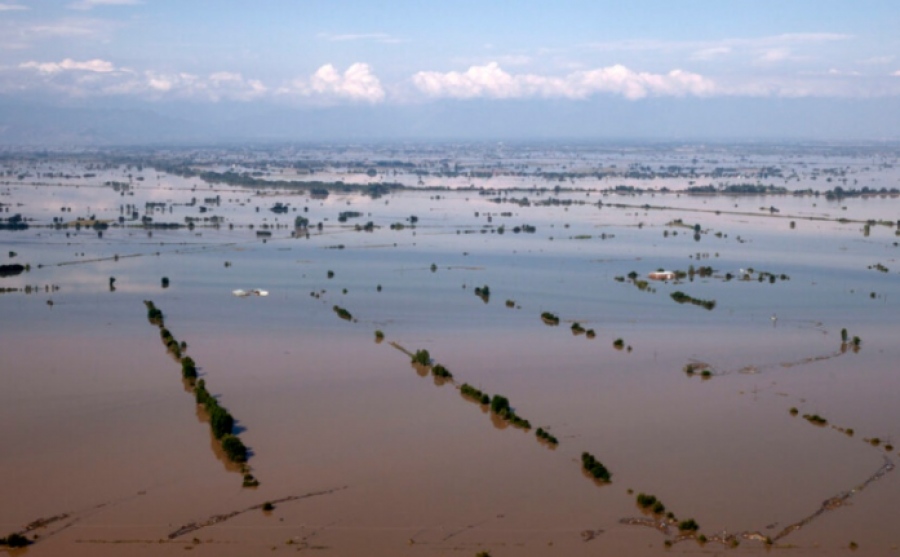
xmin=412 ymin=62 xmax=715 ymax=100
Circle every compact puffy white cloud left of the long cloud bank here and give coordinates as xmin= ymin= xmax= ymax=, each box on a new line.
xmin=278 ymin=62 xmax=385 ymax=103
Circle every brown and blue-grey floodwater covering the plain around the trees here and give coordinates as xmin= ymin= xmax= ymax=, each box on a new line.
xmin=0 ymin=149 xmax=900 ymax=557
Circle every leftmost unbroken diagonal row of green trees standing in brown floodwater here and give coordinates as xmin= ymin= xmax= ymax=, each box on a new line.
xmin=144 ymin=300 xmax=259 ymax=487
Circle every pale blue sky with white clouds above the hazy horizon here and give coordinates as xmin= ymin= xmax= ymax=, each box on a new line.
xmin=0 ymin=0 xmax=900 ymax=143
